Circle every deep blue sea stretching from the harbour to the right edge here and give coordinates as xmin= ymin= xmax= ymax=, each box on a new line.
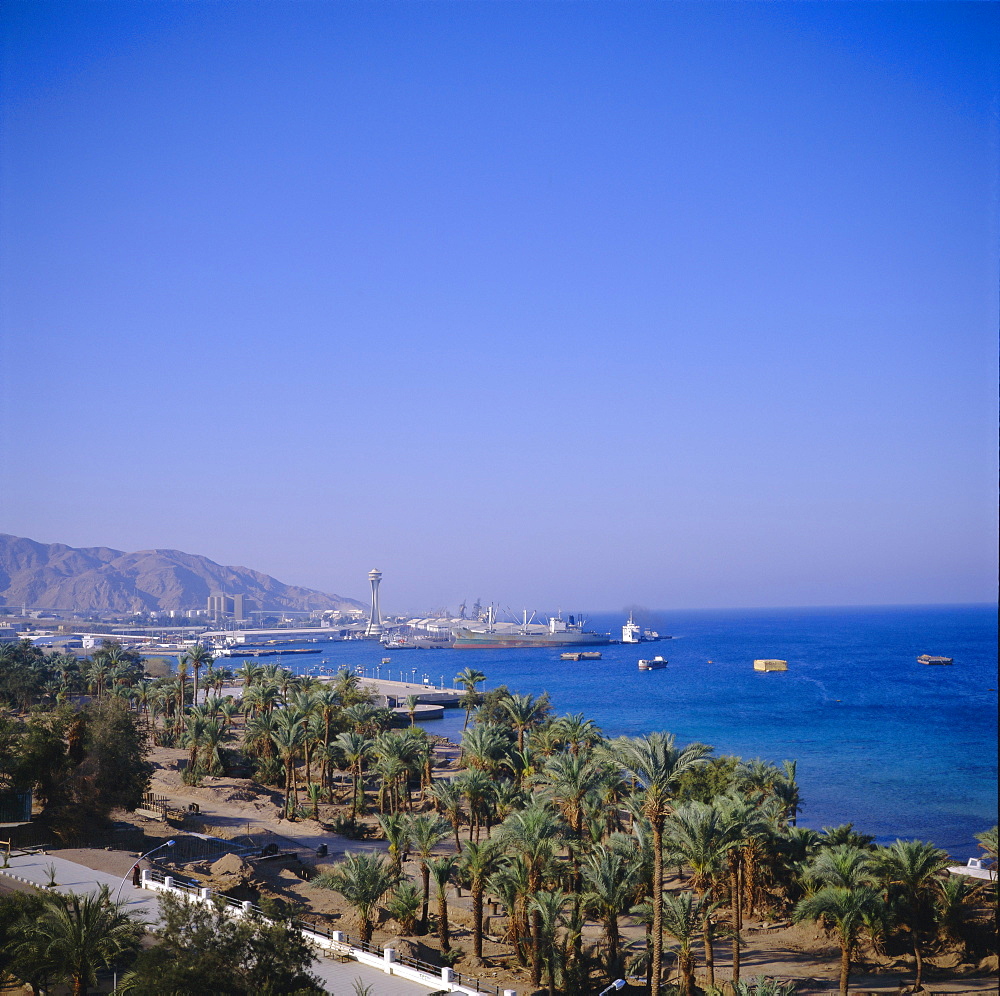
xmin=227 ymin=605 xmax=997 ymax=863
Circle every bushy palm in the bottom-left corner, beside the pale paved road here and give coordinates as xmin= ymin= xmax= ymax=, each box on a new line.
xmin=23 ymin=887 xmax=144 ymax=996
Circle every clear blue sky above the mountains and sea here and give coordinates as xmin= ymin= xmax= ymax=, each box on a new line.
xmin=0 ymin=0 xmax=1000 ymax=610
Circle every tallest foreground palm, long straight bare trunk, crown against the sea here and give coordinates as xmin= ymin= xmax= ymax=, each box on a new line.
xmin=610 ymin=733 xmax=711 ymax=996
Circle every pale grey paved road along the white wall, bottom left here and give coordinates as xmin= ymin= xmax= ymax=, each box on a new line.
xmin=0 ymin=853 xmax=433 ymax=996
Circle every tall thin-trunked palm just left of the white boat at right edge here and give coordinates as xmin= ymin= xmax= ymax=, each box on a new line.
xmin=872 ymin=840 xmax=949 ymax=992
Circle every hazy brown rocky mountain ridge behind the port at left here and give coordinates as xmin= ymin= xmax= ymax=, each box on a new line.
xmin=0 ymin=533 xmax=363 ymax=612
